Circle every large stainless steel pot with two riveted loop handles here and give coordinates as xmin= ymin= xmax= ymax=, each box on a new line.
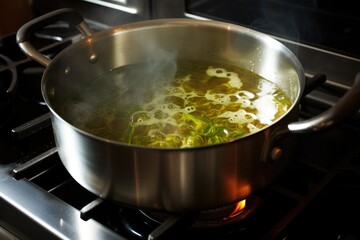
xmin=17 ymin=9 xmax=360 ymax=212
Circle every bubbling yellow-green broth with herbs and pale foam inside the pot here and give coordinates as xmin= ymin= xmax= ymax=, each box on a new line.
xmin=60 ymin=61 xmax=291 ymax=148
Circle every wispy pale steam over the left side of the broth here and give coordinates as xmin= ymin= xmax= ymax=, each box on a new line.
xmin=64 ymin=44 xmax=177 ymax=127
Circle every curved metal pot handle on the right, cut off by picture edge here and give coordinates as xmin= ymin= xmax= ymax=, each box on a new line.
xmin=287 ymin=72 xmax=360 ymax=133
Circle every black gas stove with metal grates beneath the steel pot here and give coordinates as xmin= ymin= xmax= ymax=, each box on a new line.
xmin=0 ymin=0 xmax=360 ymax=240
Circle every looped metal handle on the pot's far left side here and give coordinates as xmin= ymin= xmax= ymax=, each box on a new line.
xmin=16 ymin=8 xmax=93 ymax=67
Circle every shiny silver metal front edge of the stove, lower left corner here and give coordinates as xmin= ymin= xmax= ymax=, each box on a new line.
xmin=0 ymin=164 xmax=124 ymax=240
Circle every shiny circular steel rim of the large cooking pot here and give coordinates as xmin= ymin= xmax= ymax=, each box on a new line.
xmin=41 ymin=18 xmax=305 ymax=151
